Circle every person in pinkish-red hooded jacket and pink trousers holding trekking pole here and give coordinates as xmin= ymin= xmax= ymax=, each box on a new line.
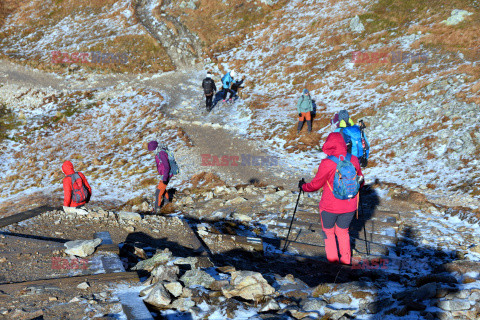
xmin=299 ymin=132 xmax=363 ymax=264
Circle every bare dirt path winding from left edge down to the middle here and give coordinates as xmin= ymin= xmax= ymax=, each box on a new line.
xmin=0 ymin=61 xmax=296 ymax=188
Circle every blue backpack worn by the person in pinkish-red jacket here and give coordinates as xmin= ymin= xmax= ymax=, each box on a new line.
xmin=327 ymin=153 xmax=360 ymax=200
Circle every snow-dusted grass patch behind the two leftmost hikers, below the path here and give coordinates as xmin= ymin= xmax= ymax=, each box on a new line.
xmin=0 ymin=87 xmax=194 ymax=205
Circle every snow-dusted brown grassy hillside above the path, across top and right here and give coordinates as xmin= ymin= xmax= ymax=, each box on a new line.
xmin=0 ymin=1 xmax=480 ymax=209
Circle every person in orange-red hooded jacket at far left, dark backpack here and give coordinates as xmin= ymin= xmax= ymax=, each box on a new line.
xmin=62 ymin=161 xmax=92 ymax=214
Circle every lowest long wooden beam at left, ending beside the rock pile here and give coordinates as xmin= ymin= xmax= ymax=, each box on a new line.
xmin=0 ymin=272 xmax=140 ymax=294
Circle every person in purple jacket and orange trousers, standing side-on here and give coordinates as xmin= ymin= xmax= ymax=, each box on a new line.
xmin=148 ymin=141 xmax=170 ymax=213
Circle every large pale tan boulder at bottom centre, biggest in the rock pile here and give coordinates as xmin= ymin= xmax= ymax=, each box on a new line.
xmin=222 ymin=271 xmax=275 ymax=300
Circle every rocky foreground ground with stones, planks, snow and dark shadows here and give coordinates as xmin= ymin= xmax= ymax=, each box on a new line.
xmin=0 ymin=179 xmax=480 ymax=319
